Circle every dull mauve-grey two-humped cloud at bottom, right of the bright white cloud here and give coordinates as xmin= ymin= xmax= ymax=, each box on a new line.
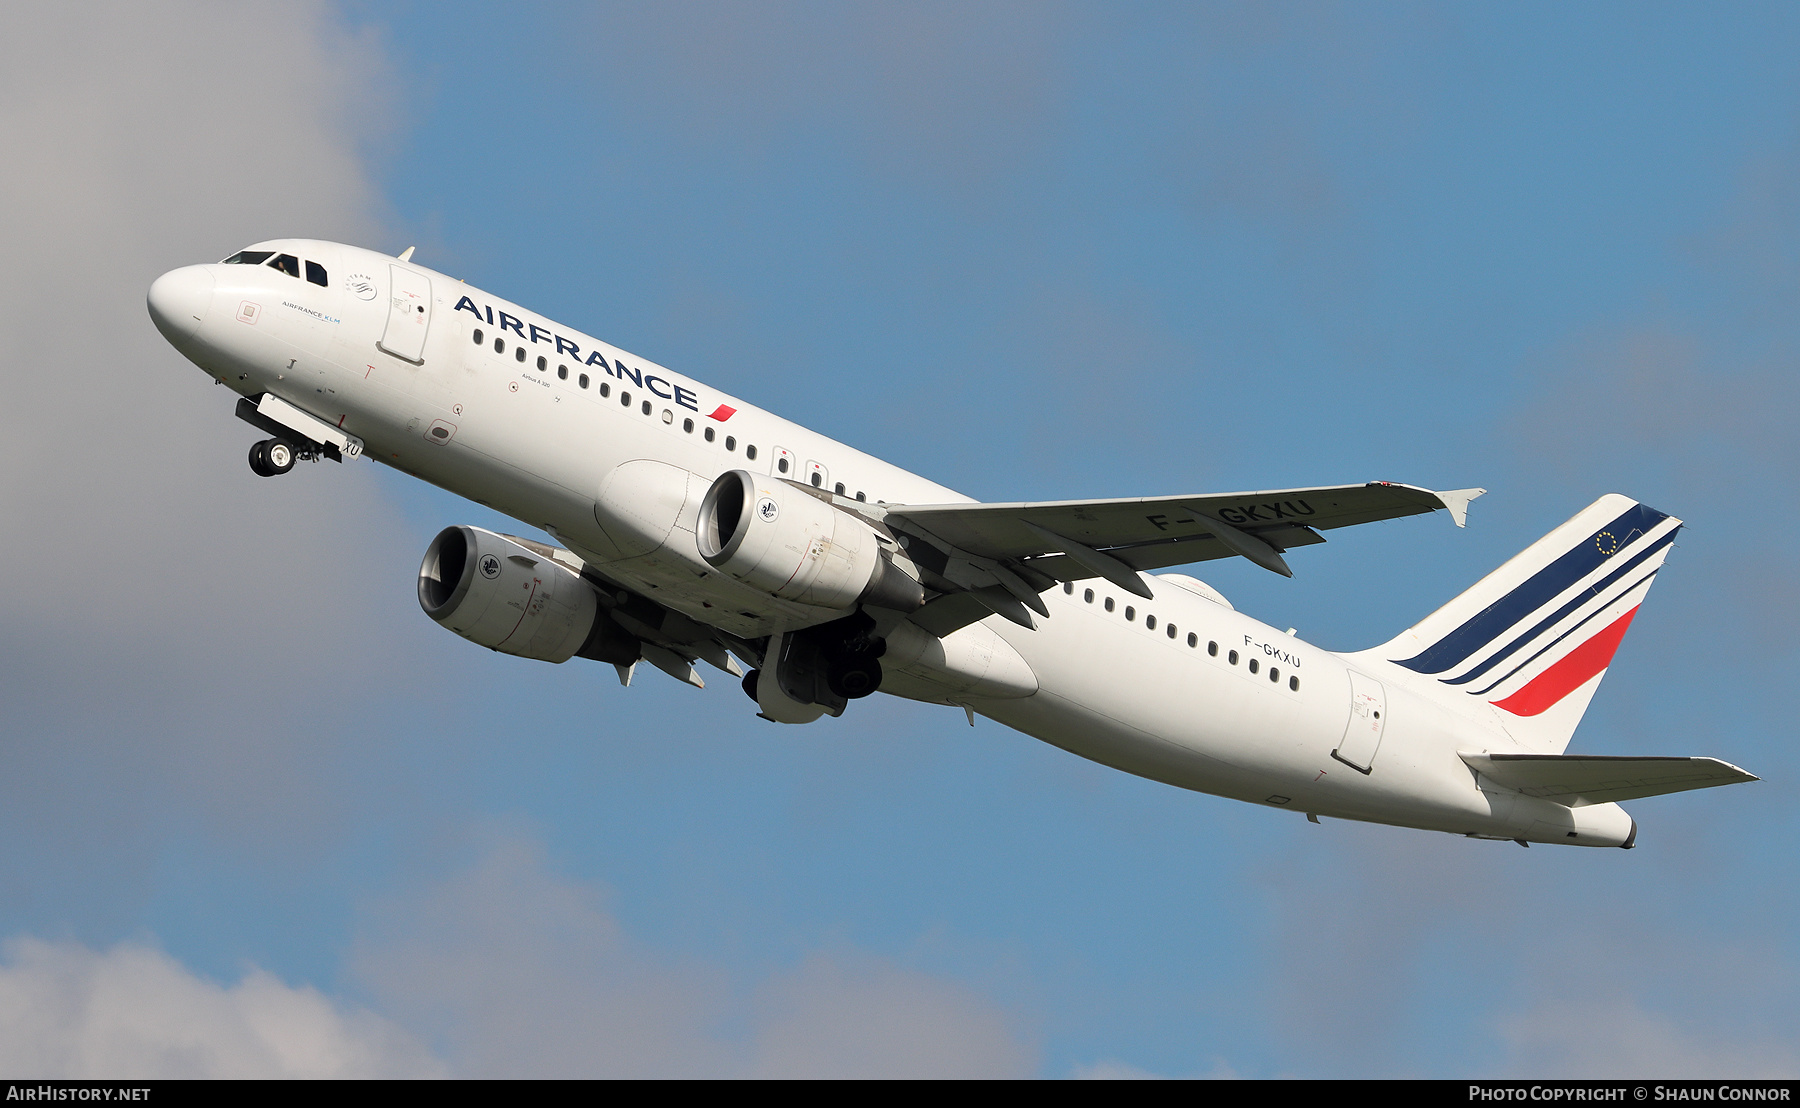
xmin=356 ymin=836 xmax=1033 ymax=1077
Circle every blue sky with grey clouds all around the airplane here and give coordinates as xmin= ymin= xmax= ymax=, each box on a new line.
xmin=0 ymin=4 xmax=1800 ymax=1077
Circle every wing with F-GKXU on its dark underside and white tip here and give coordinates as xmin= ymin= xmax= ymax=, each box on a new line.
xmin=878 ymin=480 xmax=1487 ymax=635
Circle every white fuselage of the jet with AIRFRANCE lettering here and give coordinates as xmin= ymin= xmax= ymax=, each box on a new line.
xmin=153 ymin=239 xmax=1629 ymax=845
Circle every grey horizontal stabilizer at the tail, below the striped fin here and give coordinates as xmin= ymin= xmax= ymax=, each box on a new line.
xmin=1462 ymin=752 xmax=1759 ymax=808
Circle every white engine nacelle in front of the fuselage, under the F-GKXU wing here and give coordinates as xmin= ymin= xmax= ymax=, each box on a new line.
xmin=697 ymin=469 xmax=925 ymax=612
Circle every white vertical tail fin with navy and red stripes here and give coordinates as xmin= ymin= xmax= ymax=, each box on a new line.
xmin=1368 ymin=493 xmax=1681 ymax=754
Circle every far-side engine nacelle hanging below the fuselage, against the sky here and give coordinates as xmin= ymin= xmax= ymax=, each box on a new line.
xmin=419 ymin=527 xmax=637 ymax=666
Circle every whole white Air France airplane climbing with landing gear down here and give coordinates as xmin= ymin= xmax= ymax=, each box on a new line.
xmin=149 ymin=239 xmax=1755 ymax=847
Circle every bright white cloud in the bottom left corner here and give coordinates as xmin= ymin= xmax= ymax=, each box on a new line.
xmin=0 ymin=939 xmax=445 ymax=1077
